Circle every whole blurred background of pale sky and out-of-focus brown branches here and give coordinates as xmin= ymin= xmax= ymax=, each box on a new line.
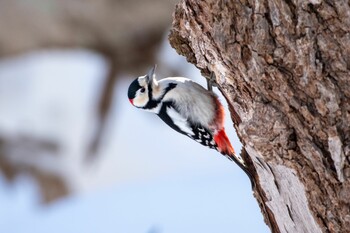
xmin=0 ymin=0 xmax=268 ymax=233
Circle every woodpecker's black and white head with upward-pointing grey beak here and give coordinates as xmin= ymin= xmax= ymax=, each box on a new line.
xmin=128 ymin=65 xmax=158 ymax=108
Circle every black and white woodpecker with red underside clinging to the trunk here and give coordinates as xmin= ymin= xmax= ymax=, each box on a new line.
xmin=128 ymin=66 xmax=254 ymax=186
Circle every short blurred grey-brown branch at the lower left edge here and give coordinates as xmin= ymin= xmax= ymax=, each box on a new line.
xmin=0 ymin=136 xmax=69 ymax=203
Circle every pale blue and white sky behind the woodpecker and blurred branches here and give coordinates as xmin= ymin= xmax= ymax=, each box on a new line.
xmin=0 ymin=41 xmax=269 ymax=233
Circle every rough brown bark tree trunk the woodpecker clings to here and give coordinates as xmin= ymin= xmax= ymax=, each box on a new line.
xmin=169 ymin=0 xmax=350 ymax=233
